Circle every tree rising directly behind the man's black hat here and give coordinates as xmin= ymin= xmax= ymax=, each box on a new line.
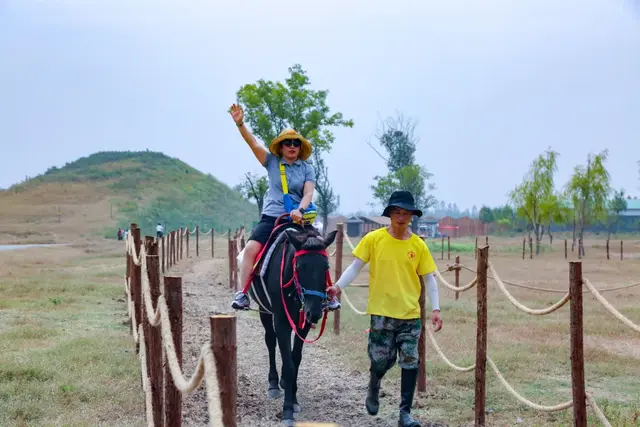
xmin=369 ymin=114 xmax=436 ymax=232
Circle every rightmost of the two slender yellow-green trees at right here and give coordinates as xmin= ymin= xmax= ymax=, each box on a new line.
xmin=566 ymin=149 xmax=611 ymax=256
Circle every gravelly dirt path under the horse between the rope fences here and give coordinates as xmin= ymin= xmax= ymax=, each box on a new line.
xmin=169 ymin=259 xmax=444 ymax=427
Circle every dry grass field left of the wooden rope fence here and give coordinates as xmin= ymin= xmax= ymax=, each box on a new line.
xmin=0 ymin=242 xmax=144 ymax=426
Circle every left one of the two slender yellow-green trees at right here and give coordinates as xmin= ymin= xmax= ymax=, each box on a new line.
xmin=509 ymin=148 xmax=558 ymax=255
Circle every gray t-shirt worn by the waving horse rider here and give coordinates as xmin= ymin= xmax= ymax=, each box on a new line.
xmin=262 ymin=153 xmax=316 ymax=217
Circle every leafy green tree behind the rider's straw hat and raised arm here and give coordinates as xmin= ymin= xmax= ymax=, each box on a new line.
xmin=236 ymin=64 xmax=353 ymax=152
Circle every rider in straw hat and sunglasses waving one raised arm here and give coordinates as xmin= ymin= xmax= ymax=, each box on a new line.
xmin=229 ymin=104 xmax=340 ymax=310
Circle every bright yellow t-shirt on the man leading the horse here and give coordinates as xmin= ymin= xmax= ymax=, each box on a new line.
xmin=353 ymin=228 xmax=437 ymax=319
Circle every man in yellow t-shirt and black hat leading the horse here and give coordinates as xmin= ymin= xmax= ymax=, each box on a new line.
xmin=328 ymin=191 xmax=442 ymax=427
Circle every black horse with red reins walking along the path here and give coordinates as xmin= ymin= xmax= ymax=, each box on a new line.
xmin=249 ymin=224 xmax=337 ymax=426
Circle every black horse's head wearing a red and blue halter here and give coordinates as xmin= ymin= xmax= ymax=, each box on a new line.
xmin=286 ymin=230 xmax=337 ymax=324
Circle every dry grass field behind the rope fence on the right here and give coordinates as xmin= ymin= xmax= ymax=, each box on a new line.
xmin=328 ymin=237 xmax=640 ymax=426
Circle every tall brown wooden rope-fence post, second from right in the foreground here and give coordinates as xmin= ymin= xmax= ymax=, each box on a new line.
xmin=474 ymin=246 xmax=489 ymax=427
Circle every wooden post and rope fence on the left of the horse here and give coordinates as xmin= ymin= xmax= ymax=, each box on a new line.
xmin=125 ymin=224 xmax=237 ymax=427
